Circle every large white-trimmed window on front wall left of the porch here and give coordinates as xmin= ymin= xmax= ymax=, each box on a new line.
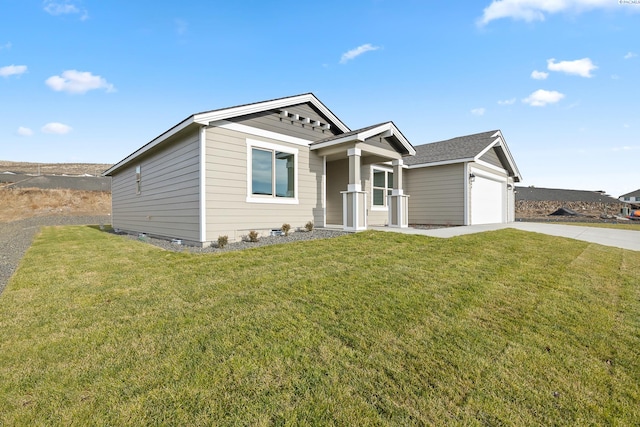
xmin=247 ymin=140 xmax=298 ymax=203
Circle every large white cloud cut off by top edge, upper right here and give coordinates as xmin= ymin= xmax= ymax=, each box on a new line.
xmin=477 ymin=0 xmax=618 ymax=26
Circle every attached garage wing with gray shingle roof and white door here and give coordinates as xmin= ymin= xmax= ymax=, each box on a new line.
xmin=405 ymin=130 xmax=522 ymax=225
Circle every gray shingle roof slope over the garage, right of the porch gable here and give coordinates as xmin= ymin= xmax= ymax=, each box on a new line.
xmin=405 ymin=130 xmax=498 ymax=166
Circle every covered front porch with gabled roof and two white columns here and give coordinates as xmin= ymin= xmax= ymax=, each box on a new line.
xmin=311 ymin=122 xmax=415 ymax=231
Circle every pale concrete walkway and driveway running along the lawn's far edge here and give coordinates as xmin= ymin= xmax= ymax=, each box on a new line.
xmin=369 ymin=222 xmax=640 ymax=251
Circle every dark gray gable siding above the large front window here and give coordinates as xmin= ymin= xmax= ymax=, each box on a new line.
xmin=228 ymin=104 xmax=342 ymax=141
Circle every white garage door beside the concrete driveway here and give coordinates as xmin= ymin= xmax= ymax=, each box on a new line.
xmin=471 ymin=174 xmax=504 ymax=224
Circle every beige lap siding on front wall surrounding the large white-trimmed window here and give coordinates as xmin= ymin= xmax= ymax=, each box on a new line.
xmin=205 ymin=128 xmax=324 ymax=241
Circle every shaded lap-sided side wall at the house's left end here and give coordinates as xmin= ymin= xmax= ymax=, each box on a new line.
xmin=111 ymin=131 xmax=200 ymax=242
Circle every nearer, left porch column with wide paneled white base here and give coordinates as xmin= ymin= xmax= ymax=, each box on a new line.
xmin=341 ymin=148 xmax=367 ymax=231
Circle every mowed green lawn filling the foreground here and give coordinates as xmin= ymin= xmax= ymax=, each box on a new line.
xmin=0 ymin=227 xmax=640 ymax=426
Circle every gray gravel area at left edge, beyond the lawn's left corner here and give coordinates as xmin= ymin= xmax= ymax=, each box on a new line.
xmin=0 ymin=216 xmax=111 ymax=294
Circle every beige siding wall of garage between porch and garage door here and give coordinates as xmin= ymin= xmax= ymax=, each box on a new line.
xmin=404 ymin=163 xmax=466 ymax=225
